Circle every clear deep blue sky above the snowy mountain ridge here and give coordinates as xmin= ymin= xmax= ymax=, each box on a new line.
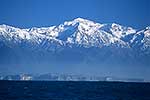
xmin=0 ymin=0 xmax=150 ymax=29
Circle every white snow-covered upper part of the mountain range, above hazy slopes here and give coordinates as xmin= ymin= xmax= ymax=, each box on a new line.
xmin=0 ymin=18 xmax=150 ymax=52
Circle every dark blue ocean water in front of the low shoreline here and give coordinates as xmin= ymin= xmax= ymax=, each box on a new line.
xmin=0 ymin=81 xmax=150 ymax=100
